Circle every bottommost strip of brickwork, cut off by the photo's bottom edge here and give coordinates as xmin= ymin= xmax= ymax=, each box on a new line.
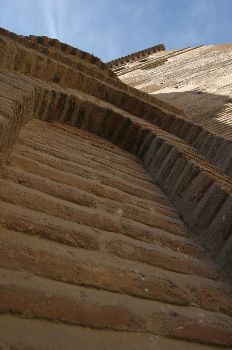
xmin=0 ymin=316 xmax=218 ymax=350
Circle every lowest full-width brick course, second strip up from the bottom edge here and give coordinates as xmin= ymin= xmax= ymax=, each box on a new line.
xmin=0 ymin=269 xmax=232 ymax=345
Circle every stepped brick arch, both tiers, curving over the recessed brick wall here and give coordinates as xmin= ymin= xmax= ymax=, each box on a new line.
xmin=1 ymin=32 xmax=232 ymax=272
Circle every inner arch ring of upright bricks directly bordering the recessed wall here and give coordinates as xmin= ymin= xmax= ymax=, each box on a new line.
xmin=2 ymin=77 xmax=232 ymax=276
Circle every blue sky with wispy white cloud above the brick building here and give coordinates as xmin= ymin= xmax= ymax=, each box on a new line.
xmin=0 ymin=0 xmax=232 ymax=61
